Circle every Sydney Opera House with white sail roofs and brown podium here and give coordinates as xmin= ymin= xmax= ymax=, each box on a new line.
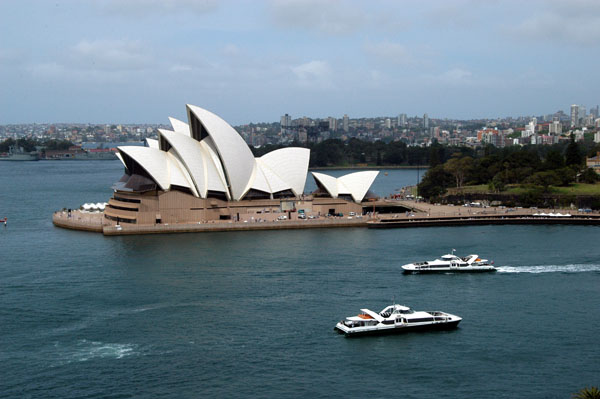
xmin=104 ymin=105 xmax=378 ymax=225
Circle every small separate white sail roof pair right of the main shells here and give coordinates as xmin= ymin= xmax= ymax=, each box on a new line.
xmin=312 ymin=171 xmax=379 ymax=202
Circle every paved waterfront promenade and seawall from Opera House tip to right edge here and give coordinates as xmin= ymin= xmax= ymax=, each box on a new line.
xmin=52 ymin=200 xmax=600 ymax=236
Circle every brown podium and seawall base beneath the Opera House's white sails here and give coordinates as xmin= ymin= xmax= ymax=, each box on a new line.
xmin=52 ymin=190 xmax=370 ymax=235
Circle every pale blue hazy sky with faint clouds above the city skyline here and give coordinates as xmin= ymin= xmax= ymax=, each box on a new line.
xmin=0 ymin=0 xmax=600 ymax=125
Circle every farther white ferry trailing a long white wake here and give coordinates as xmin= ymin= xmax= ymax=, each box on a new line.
xmin=402 ymin=250 xmax=496 ymax=273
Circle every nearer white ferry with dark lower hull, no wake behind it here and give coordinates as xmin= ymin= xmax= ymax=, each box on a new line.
xmin=335 ymin=304 xmax=462 ymax=337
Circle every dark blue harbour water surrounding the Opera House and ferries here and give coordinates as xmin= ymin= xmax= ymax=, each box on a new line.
xmin=0 ymin=161 xmax=600 ymax=398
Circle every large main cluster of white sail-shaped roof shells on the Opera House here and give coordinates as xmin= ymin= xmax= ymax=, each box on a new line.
xmin=117 ymin=105 xmax=310 ymax=200
